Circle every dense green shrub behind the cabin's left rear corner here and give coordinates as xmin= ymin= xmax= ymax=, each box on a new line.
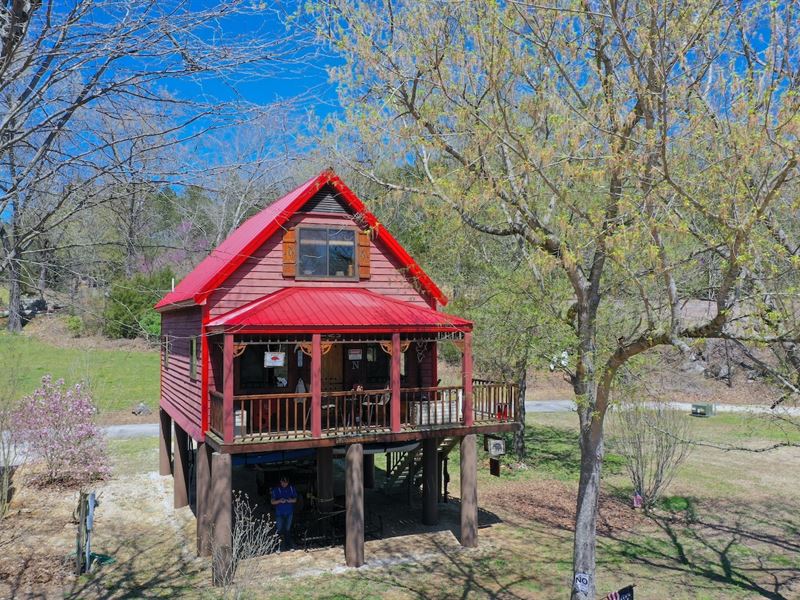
xmin=103 ymin=269 xmax=173 ymax=339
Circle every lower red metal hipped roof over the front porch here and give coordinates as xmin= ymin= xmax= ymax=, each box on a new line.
xmin=203 ymin=287 xmax=472 ymax=332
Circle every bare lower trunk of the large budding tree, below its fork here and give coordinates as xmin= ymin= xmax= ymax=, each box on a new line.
xmin=570 ymin=413 xmax=603 ymax=600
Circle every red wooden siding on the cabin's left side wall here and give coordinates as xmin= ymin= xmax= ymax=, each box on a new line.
xmin=161 ymin=306 xmax=203 ymax=441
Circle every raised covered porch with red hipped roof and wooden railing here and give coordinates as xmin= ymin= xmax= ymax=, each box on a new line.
xmin=204 ymin=288 xmax=518 ymax=445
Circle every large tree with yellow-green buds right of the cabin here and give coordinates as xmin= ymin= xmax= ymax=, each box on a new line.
xmin=319 ymin=0 xmax=800 ymax=600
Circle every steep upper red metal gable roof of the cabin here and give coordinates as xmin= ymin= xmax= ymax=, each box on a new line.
xmin=155 ymin=170 xmax=447 ymax=309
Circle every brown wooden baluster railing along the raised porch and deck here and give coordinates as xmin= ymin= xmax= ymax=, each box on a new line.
xmin=209 ymin=383 xmax=518 ymax=441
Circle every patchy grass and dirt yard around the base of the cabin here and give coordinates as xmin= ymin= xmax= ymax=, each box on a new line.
xmin=0 ymin=400 xmax=800 ymax=600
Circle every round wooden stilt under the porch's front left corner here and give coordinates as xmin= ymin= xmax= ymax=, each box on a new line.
xmin=208 ymin=452 xmax=233 ymax=585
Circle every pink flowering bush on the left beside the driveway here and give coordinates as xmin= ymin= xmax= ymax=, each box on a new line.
xmin=15 ymin=375 xmax=110 ymax=483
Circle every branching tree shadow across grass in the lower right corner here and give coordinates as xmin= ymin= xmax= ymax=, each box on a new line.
xmin=609 ymin=496 xmax=800 ymax=600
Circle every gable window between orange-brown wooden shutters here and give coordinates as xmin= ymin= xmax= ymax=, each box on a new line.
xmin=297 ymin=227 xmax=358 ymax=279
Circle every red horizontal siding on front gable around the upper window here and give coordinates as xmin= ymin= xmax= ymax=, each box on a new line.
xmin=208 ymin=214 xmax=435 ymax=318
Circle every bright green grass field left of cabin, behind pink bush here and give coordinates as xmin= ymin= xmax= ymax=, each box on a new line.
xmin=0 ymin=332 xmax=159 ymax=412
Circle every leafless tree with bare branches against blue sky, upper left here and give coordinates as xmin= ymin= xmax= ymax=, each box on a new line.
xmin=0 ymin=0 xmax=306 ymax=330
